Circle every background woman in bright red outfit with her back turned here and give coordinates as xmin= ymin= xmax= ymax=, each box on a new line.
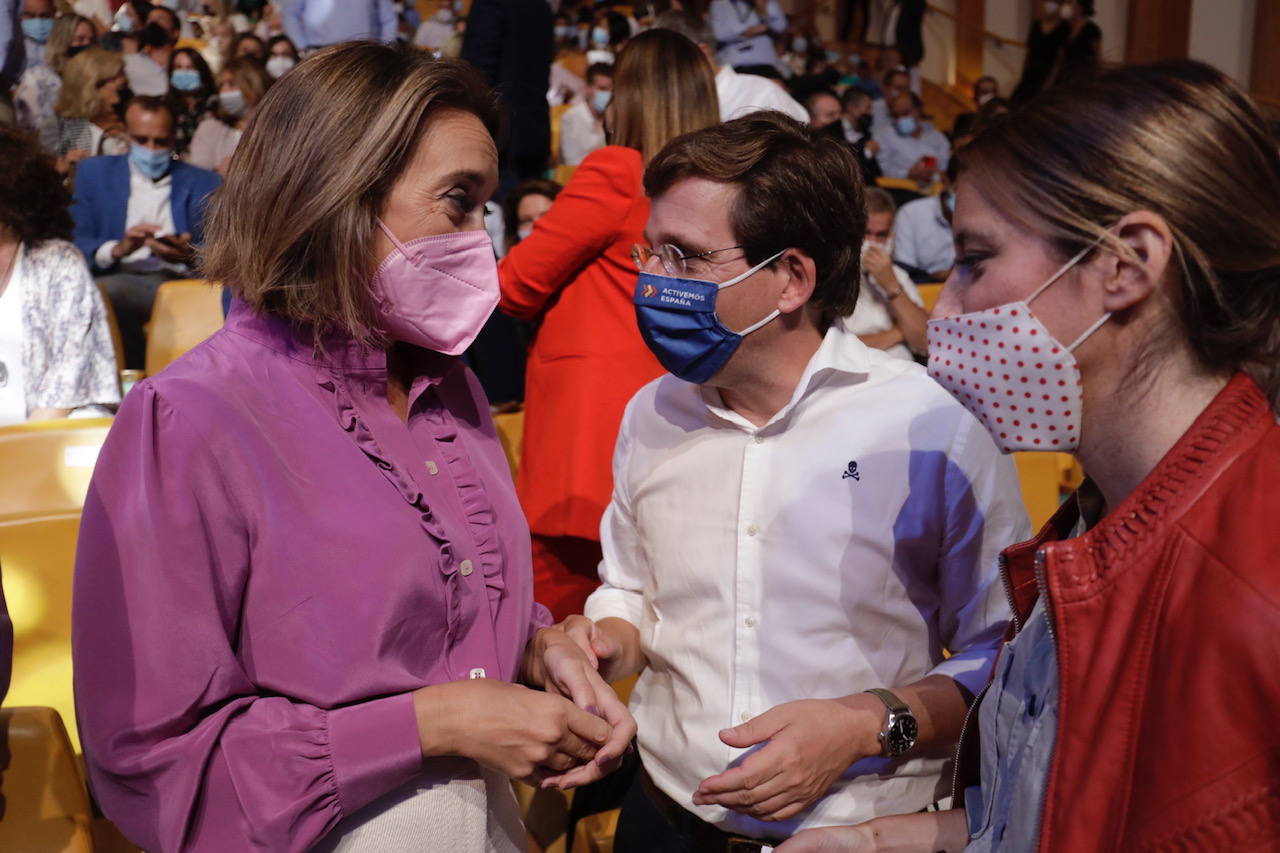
xmin=499 ymin=29 xmax=719 ymax=619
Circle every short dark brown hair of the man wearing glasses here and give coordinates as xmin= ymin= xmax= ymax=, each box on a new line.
xmin=644 ymin=111 xmax=867 ymax=315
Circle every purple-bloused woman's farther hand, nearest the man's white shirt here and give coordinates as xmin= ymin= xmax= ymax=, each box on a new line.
xmin=525 ymin=617 xmax=636 ymax=788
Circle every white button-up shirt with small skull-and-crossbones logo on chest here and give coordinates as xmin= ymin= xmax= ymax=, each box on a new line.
xmin=586 ymin=323 xmax=1029 ymax=838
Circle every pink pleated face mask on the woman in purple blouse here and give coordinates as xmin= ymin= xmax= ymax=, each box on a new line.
xmin=370 ymin=219 xmax=498 ymax=355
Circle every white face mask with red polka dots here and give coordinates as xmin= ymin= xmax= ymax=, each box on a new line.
xmin=928 ymin=243 xmax=1111 ymax=453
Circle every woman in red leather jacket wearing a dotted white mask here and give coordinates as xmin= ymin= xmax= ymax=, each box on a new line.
xmin=780 ymin=61 xmax=1280 ymax=853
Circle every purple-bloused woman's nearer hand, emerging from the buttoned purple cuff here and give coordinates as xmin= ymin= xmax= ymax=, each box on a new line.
xmin=413 ymin=679 xmax=612 ymax=785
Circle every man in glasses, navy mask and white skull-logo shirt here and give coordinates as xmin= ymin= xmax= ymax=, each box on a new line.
xmin=542 ymin=113 xmax=1029 ymax=853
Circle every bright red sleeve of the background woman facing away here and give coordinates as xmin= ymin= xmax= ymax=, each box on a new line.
xmin=498 ymin=146 xmax=643 ymax=320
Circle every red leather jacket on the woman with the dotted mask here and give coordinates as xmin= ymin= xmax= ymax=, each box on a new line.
xmin=961 ymin=374 xmax=1280 ymax=853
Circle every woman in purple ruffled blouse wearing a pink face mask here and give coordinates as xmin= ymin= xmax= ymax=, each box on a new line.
xmin=73 ymin=42 xmax=635 ymax=853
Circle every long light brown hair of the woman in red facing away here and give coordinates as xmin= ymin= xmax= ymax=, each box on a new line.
xmin=611 ymin=29 xmax=719 ymax=163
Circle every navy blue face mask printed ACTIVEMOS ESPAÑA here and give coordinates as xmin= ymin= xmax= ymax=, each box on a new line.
xmin=635 ymin=250 xmax=786 ymax=386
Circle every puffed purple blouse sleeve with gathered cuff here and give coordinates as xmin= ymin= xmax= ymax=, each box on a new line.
xmin=72 ymin=382 xmax=422 ymax=853
